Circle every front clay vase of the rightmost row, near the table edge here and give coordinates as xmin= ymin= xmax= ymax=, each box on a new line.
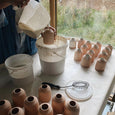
xmin=95 ymin=58 xmax=107 ymax=72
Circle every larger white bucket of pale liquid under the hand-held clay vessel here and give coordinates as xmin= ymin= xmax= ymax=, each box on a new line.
xmin=36 ymin=36 xmax=67 ymax=75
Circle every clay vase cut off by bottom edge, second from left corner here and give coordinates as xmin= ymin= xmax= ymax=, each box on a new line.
xmin=8 ymin=107 xmax=25 ymax=115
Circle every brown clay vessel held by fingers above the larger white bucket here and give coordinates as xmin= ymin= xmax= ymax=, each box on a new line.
xmin=41 ymin=27 xmax=56 ymax=44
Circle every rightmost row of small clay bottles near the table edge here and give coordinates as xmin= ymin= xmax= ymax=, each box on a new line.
xmin=95 ymin=44 xmax=113 ymax=72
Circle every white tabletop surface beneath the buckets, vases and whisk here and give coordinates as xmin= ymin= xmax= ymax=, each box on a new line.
xmin=0 ymin=48 xmax=115 ymax=115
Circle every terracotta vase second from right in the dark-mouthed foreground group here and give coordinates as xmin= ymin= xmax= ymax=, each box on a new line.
xmin=52 ymin=94 xmax=65 ymax=114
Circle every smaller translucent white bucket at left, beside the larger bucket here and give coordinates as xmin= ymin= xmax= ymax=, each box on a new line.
xmin=5 ymin=54 xmax=34 ymax=86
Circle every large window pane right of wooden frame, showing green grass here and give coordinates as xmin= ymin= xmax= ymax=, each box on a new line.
xmin=57 ymin=0 xmax=115 ymax=46
